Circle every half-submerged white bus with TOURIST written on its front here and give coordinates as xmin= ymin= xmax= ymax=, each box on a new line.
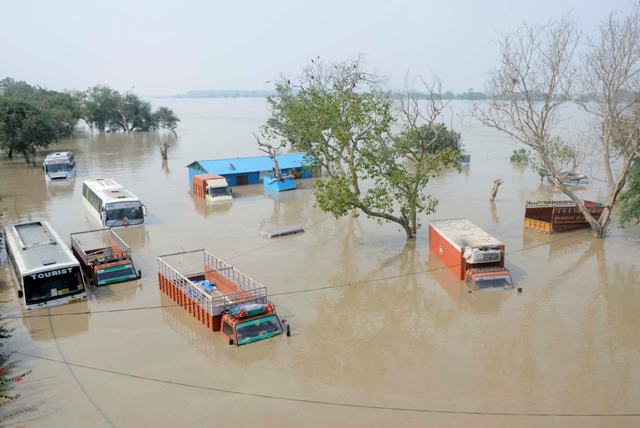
xmin=5 ymin=221 xmax=87 ymax=309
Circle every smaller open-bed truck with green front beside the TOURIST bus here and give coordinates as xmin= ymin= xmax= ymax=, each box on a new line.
xmin=71 ymin=229 xmax=141 ymax=286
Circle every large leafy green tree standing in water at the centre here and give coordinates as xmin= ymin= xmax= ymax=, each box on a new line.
xmin=262 ymin=60 xmax=460 ymax=238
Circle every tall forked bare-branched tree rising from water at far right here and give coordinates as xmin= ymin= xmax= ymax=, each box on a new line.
xmin=476 ymin=6 xmax=640 ymax=237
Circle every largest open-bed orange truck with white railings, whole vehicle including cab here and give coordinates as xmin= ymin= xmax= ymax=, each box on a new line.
xmin=158 ymin=250 xmax=289 ymax=346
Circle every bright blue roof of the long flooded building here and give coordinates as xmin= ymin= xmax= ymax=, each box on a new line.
xmin=187 ymin=153 xmax=307 ymax=175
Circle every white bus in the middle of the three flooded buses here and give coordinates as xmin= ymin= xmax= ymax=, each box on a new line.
xmin=82 ymin=178 xmax=146 ymax=227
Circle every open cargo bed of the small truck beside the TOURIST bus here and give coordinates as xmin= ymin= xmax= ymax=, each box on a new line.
xmin=71 ymin=229 xmax=131 ymax=265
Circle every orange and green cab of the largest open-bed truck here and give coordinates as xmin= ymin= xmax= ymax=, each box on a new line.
xmin=220 ymin=303 xmax=291 ymax=346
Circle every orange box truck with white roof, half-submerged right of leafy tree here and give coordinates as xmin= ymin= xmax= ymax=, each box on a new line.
xmin=429 ymin=218 xmax=513 ymax=291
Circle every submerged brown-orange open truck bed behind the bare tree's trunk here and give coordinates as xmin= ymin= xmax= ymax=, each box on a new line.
xmin=524 ymin=201 xmax=604 ymax=233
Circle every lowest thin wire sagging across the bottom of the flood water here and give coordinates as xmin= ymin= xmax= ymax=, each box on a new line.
xmin=16 ymin=352 xmax=640 ymax=417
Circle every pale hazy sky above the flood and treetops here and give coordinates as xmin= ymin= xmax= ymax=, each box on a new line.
xmin=0 ymin=0 xmax=631 ymax=95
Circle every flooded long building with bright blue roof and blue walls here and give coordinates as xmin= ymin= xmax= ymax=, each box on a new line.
xmin=187 ymin=153 xmax=313 ymax=186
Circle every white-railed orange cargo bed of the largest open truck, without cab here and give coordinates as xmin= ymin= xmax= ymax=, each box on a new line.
xmin=158 ymin=249 xmax=267 ymax=316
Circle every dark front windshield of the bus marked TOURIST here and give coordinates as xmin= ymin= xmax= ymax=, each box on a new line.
xmin=23 ymin=267 xmax=84 ymax=305
